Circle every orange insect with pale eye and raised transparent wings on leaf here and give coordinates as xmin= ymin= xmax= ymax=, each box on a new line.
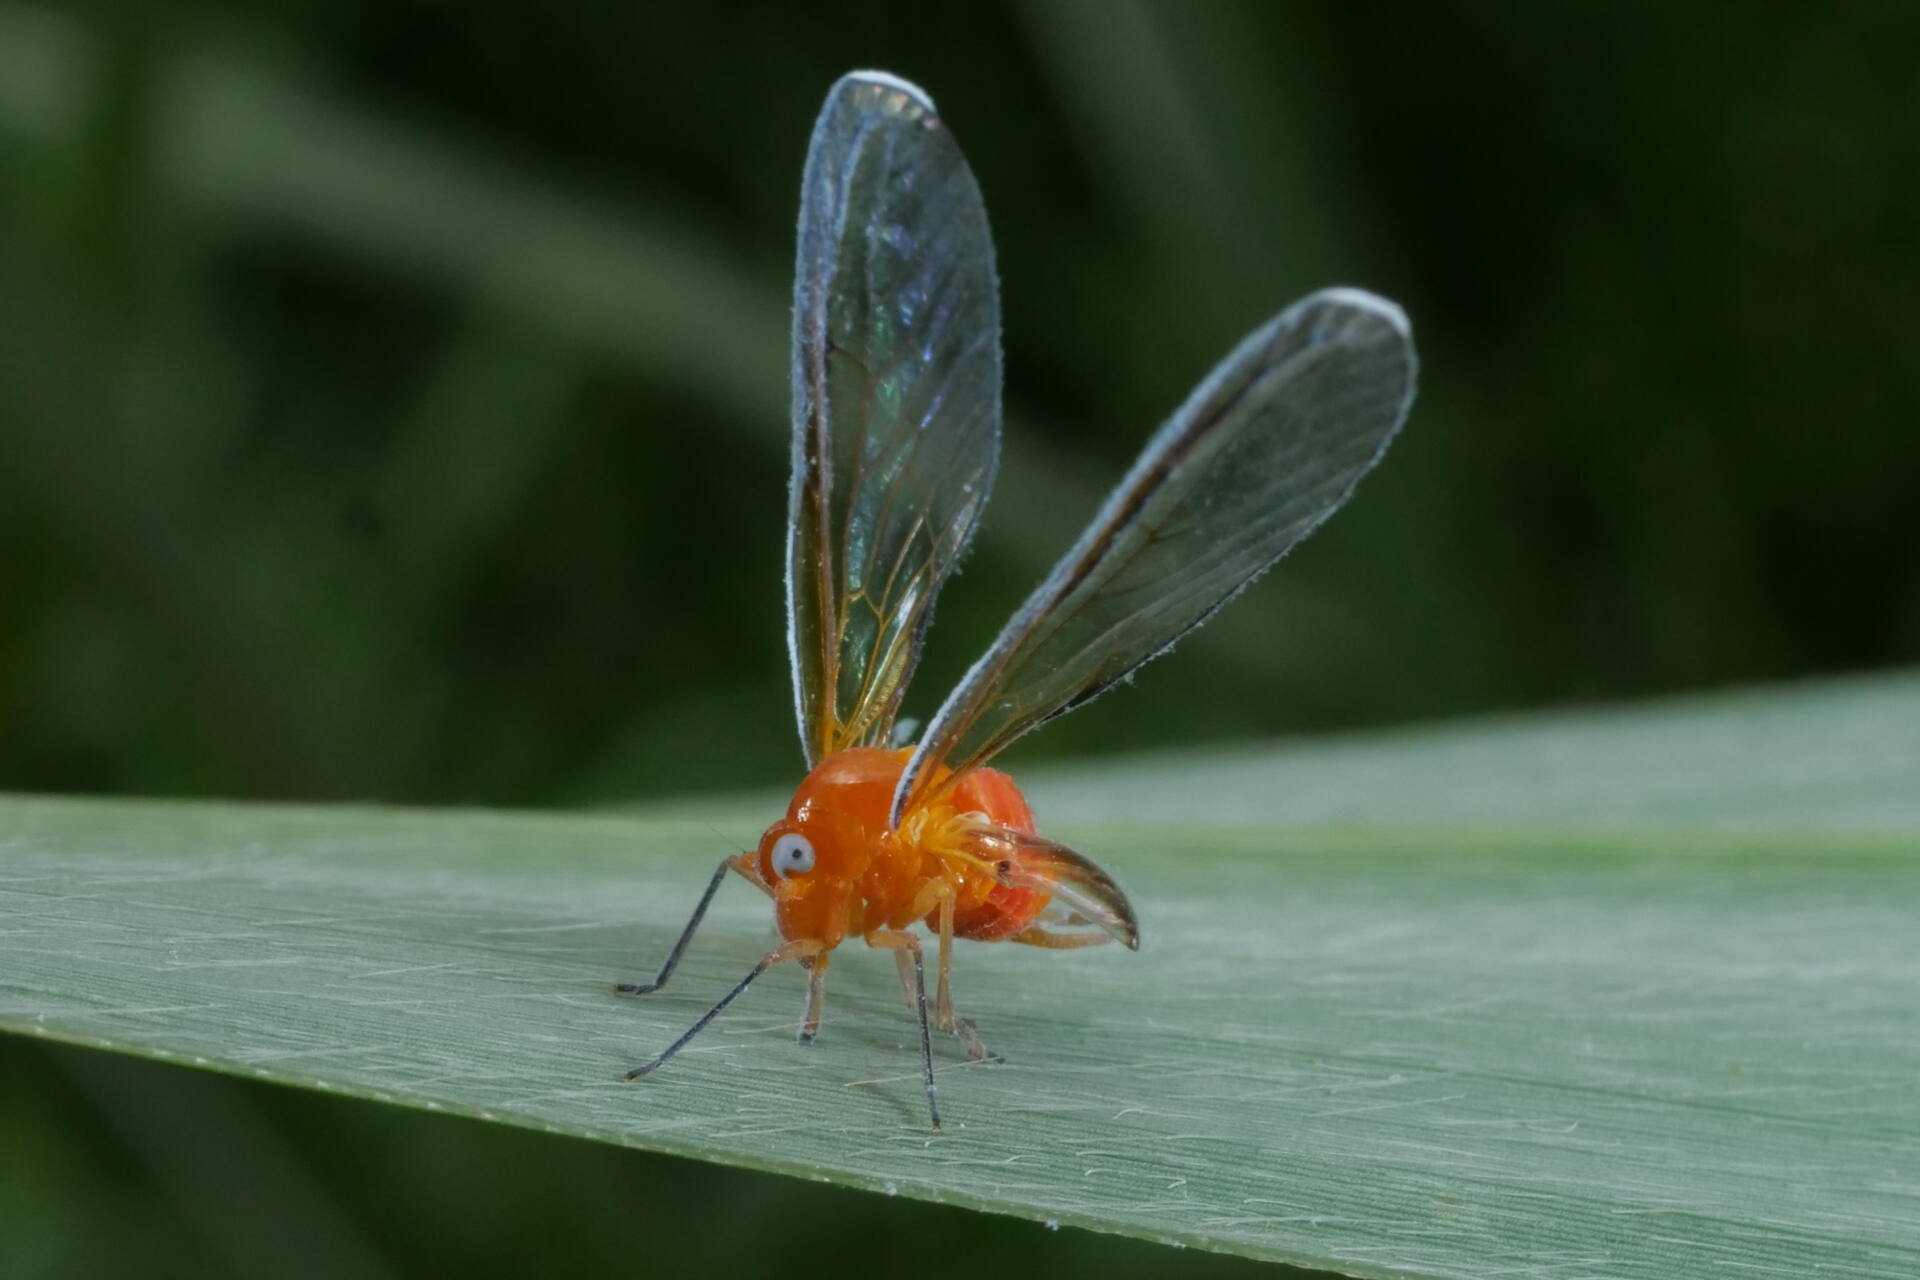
xmin=616 ymin=71 xmax=1415 ymax=1128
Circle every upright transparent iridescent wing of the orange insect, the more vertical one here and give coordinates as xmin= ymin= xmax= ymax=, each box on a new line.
xmin=787 ymin=71 xmax=1000 ymax=766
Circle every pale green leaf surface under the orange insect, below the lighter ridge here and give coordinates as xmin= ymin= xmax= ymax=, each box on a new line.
xmin=0 ymin=786 xmax=1920 ymax=1276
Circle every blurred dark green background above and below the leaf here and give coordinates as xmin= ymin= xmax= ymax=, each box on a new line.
xmin=0 ymin=0 xmax=1920 ymax=1276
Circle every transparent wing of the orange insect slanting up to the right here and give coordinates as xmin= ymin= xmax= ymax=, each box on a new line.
xmin=893 ymin=290 xmax=1415 ymax=823
